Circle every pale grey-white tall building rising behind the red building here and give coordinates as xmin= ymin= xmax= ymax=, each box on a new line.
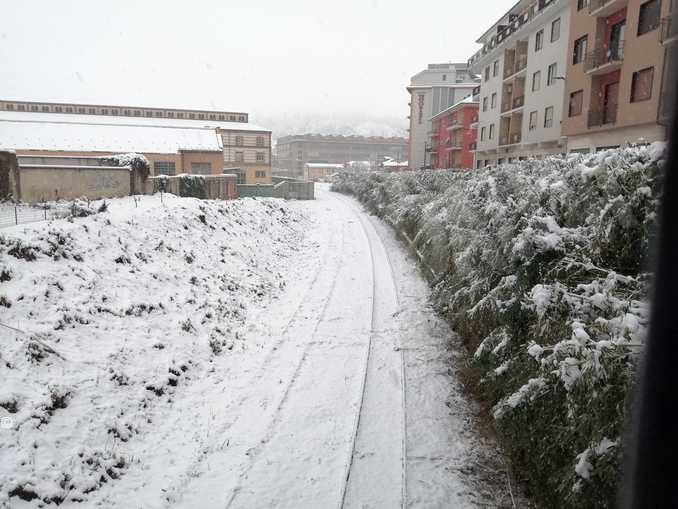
xmin=407 ymin=63 xmax=478 ymax=170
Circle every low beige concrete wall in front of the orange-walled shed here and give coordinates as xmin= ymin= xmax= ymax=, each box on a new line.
xmin=19 ymin=165 xmax=131 ymax=203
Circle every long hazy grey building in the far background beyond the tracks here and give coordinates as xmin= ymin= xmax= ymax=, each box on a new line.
xmin=276 ymin=134 xmax=407 ymax=176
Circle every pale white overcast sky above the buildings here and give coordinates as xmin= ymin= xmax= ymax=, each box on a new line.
xmin=0 ymin=0 xmax=513 ymax=129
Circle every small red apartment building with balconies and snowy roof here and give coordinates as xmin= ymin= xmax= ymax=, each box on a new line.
xmin=430 ymin=96 xmax=478 ymax=169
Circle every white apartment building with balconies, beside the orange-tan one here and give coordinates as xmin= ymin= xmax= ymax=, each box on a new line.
xmin=469 ymin=0 xmax=570 ymax=168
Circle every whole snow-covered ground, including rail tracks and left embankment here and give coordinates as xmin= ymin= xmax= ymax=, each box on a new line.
xmin=0 ymin=189 xmax=520 ymax=508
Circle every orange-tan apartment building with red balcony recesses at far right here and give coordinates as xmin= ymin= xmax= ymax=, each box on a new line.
xmin=562 ymin=0 xmax=675 ymax=152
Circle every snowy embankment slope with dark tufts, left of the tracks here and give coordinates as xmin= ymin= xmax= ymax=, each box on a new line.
xmin=0 ymin=196 xmax=321 ymax=505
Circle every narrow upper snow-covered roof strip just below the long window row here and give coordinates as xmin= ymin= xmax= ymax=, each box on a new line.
xmin=0 ymin=111 xmax=271 ymax=132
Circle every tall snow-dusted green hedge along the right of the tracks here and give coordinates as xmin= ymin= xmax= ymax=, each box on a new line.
xmin=334 ymin=144 xmax=664 ymax=507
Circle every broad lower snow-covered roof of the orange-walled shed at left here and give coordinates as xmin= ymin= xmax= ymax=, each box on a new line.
xmin=0 ymin=117 xmax=223 ymax=154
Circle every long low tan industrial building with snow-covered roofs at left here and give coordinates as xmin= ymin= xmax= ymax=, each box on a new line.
xmin=0 ymin=100 xmax=271 ymax=184
